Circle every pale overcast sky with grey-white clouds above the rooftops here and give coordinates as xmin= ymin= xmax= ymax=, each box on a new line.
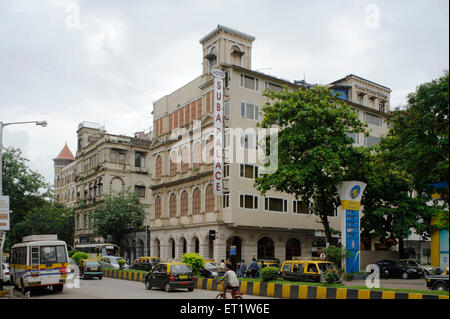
xmin=0 ymin=0 xmax=449 ymax=183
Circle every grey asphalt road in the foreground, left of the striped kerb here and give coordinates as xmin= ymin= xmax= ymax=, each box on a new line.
xmin=9 ymin=277 xmax=272 ymax=299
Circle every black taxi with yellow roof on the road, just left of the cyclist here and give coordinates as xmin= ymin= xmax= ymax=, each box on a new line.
xmin=144 ymin=262 xmax=196 ymax=292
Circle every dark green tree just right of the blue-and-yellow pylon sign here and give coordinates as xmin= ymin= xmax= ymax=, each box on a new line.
xmin=361 ymin=148 xmax=436 ymax=256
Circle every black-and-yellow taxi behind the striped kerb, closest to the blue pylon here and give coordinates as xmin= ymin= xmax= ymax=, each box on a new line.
xmin=280 ymin=258 xmax=337 ymax=282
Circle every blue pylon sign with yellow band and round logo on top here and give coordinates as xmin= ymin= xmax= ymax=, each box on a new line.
xmin=338 ymin=181 xmax=366 ymax=274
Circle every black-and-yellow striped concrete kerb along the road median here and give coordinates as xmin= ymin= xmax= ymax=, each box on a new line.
xmin=104 ymin=270 xmax=449 ymax=300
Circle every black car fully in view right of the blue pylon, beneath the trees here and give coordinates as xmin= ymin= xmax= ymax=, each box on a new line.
xmin=376 ymin=259 xmax=424 ymax=279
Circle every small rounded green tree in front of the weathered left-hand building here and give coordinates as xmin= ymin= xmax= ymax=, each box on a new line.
xmin=93 ymin=191 xmax=145 ymax=245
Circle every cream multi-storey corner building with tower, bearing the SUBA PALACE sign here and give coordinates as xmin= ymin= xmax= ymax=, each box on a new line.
xmin=150 ymin=25 xmax=390 ymax=260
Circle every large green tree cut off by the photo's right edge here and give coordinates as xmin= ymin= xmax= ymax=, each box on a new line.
xmin=386 ymin=72 xmax=449 ymax=204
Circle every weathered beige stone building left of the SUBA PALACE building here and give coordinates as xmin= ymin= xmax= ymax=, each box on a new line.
xmin=54 ymin=122 xmax=151 ymax=258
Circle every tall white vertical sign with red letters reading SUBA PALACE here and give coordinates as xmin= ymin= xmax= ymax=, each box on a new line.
xmin=211 ymin=69 xmax=225 ymax=196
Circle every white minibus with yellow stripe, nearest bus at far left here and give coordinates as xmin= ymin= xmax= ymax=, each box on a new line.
xmin=9 ymin=235 xmax=70 ymax=293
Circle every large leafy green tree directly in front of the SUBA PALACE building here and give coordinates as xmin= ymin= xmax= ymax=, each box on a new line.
xmin=256 ymin=86 xmax=367 ymax=242
